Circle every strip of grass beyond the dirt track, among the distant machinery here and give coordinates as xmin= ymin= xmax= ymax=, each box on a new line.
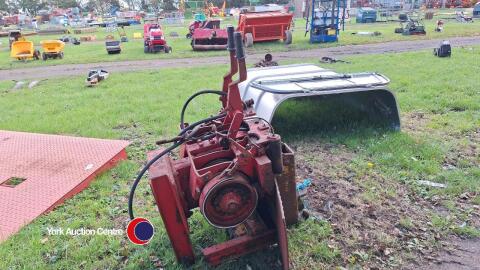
xmin=0 ymin=13 xmax=480 ymax=69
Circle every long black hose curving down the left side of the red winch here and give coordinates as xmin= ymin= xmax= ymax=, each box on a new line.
xmin=128 ymin=113 xmax=226 ymax=220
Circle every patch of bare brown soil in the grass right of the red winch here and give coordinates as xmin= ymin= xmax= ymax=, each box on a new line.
xmin=288 ymin=143 xmax=441 ymax=269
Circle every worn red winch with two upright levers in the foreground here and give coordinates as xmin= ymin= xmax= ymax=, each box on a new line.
xmin=129 ymin=26 xmax=298 ymax=269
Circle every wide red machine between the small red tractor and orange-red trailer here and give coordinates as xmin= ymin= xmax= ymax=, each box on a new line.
xmin=187 ymin=19 xmax=228 ymax=51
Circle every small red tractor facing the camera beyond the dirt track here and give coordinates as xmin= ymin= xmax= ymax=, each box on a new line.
xmin=143 ymin=23 xmax=172 ymax=53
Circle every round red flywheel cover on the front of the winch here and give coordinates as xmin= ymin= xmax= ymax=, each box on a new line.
xmin=199 ymin=173 xmax=258 ymax=228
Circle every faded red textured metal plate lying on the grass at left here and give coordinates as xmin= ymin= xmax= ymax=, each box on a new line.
xmin=0 ymin=131 xmax=128 ymax=242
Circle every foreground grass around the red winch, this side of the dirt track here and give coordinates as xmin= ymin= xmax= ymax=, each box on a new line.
xmin=0 ymin=46 xmax=480 ymax=269
